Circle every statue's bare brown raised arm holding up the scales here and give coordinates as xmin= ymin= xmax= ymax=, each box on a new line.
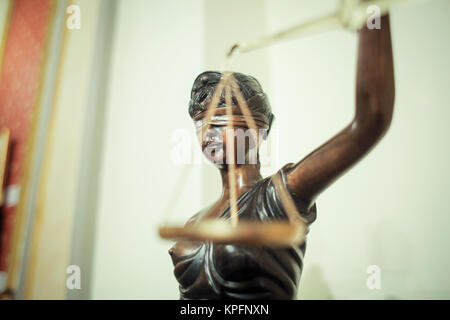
xmin=286 ymin=15 xmax=395 ymax=210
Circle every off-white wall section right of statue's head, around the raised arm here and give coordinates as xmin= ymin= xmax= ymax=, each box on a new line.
xmin=267 ymin=0 xmax=450 ymax=299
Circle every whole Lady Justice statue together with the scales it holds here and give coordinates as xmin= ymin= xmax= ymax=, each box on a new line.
xmin=158 ymin=0 xmax=420 ymax=299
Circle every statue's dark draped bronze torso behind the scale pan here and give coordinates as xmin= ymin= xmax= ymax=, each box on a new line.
xmin=171 ymin=168 xmax=316 ymax=299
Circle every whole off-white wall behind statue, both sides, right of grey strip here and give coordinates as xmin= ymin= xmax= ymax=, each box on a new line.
xmin=91 ymin=0 xmax=450 ymax=299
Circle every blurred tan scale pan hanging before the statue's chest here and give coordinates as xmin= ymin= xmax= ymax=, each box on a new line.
xmin=158 ymin=219 xmax=307 ymax=246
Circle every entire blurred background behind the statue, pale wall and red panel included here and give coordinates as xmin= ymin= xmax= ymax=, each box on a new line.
xmin=0 ymin=0 xmax=450 ymax=299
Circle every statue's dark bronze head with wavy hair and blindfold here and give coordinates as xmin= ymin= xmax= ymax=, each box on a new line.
xmin=189 ymin=71 xmax=274 ymax=166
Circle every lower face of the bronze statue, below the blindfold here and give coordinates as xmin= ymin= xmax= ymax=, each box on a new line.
xmin=197 ymin=125 xmax=262 ymax=166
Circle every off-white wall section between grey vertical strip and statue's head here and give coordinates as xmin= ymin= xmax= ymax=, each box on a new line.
xmin=91 ymin=0 xmax=204 ymax=299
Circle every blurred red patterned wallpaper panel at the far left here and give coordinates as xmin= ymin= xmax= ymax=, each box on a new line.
xmin=0 ymin=0 xmax=52 ymax=271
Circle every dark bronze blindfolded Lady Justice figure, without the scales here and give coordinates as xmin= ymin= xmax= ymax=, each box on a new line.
xmin=169 ymin=15 xmax=394 ymax=299
